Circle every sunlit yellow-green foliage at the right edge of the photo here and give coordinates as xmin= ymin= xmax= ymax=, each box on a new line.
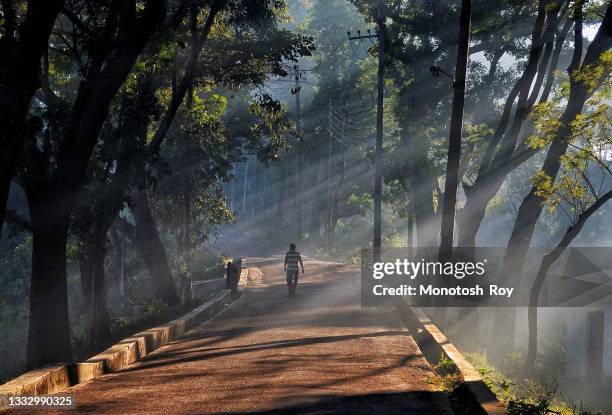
xmin=527 ymin=51 xmax=612 ymax=222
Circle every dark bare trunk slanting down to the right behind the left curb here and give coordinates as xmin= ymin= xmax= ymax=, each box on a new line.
xmin=132 ymin=189 xmax=179 ymax=306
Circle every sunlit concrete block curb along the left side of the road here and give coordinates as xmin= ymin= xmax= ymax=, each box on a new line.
xmin=0 ymin=268 xmax=249 ymax=402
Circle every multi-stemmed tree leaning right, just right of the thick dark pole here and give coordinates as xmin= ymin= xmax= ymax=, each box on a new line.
xmin=458 ymin=1 xmax=573 ymax=246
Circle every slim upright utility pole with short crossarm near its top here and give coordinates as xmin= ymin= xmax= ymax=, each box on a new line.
xmin=348 ymin=0 xmax=386 ymax=261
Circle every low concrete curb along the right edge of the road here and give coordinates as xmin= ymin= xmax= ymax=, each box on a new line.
xmin=394 ymin=298 xmax=508 ymax=415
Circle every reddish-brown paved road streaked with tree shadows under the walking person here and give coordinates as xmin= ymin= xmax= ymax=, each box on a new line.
xmin=50 ymin=259 xmax=447 ymax=415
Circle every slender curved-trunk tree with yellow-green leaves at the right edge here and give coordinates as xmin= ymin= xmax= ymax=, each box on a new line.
xmin=525 ymin=83 xmax=612 ymax=374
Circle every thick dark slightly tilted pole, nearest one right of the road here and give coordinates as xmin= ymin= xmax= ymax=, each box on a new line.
xmin=438 ymin=0 xmax=472 ymax=260
